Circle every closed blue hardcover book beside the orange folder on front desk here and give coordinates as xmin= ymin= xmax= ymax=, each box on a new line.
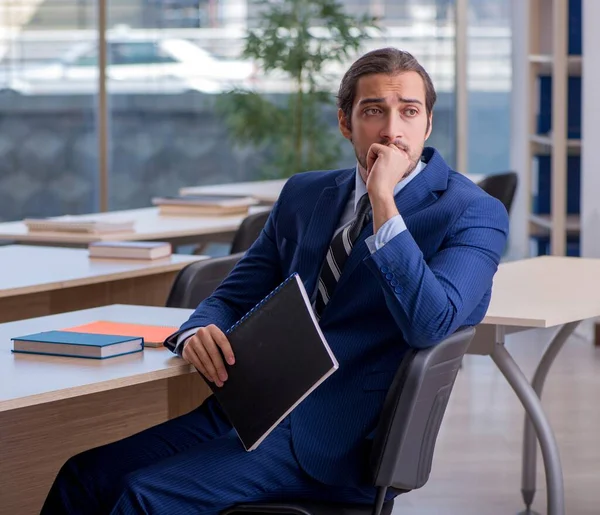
xmin=11 ymin=331 xmax=144 ymax=359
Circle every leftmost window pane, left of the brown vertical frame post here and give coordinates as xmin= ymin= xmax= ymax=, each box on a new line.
xmin=0 ymin=0 xmax=99 ymax=220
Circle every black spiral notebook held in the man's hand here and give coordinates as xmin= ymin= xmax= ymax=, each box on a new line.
xmin=207 ymin=274 xmax=338 ymax=451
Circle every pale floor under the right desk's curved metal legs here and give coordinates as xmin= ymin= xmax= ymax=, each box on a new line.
xmin=393 ymin=324 xmax=600 ymax=515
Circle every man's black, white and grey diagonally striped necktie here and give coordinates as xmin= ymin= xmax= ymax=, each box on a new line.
xmin=315 ymin=193 xmax=371 ymax=317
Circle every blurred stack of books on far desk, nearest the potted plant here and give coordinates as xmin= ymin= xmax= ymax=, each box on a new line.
xmin=152 ymin=195 xmax=258 ymax=216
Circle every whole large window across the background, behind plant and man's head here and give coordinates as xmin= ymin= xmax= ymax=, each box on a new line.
xmin=0 ymin=0 xmax=511 ymax=220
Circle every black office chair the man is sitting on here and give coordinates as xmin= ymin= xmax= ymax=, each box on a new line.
xmin=221 ymin=328 xmax=475 ymax=515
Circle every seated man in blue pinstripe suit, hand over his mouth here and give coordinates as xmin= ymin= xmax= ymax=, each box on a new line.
xmin=42 ymin=48 xmax=508 ymax=515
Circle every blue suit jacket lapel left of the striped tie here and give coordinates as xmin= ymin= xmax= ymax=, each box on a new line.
xmin=297 ymin=169 xmax=355 ymax=295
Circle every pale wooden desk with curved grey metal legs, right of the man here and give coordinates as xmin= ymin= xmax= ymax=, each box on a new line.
xmin=468 ymin=256 xmax=600 ymax=515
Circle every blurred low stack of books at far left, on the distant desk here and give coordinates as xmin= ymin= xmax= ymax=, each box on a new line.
xmin=23 ymin=215 xmax=134 ymax=234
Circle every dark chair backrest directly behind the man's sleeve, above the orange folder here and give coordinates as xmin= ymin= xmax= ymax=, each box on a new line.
xmin=166 ymin=252 xmax=244 ymax=309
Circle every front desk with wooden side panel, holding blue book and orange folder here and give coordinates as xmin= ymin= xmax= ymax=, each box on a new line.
xmin=0 ymin=305 xmax=209 ymax=515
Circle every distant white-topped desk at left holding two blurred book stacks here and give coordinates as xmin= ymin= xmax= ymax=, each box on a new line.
xmin=0 ymin=206 xmax=269 ymax=247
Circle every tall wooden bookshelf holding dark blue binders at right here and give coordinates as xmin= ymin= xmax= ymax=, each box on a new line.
xmin=513 ymin=0 xmax=583 ymax=255
